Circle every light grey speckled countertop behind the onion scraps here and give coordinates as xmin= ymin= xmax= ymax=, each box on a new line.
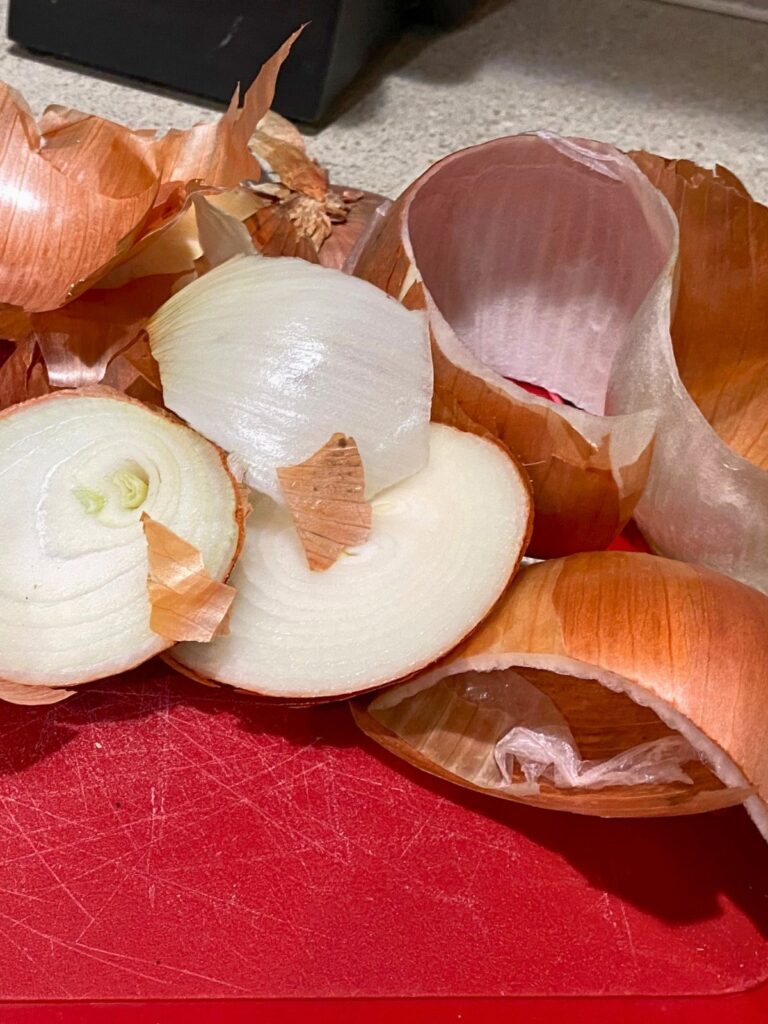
xmin=0 ymin=0 xmax=768 ymax=200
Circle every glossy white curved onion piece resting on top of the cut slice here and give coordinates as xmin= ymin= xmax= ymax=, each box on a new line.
xmin=146 ymin=256 xmax=432 ymax=502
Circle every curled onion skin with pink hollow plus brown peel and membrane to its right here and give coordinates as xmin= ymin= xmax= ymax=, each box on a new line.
xmin=355 ymin=134 xmax=768 ymax=590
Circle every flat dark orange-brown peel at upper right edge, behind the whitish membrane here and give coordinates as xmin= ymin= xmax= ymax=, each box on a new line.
xmin=630 ymin=153 xmax=768 ymax=470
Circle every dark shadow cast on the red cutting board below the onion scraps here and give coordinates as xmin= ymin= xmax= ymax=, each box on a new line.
xmin=0 ymin=662 xmax=768 ymax=938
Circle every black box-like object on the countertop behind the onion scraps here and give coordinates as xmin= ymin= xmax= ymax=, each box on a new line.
xmin=8 ymin=0 xmax=472 ymax=121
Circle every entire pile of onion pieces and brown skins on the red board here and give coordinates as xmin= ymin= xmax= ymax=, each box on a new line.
xmin=0 ymin=37 xmax=768 ymax=830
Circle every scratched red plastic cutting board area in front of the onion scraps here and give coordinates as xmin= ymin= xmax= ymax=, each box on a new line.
xmin=0 ymin=664 xmax=768 ymax=999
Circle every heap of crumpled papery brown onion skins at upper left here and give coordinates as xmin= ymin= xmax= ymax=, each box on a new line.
xmin=0 ymin=25 xmax=382 ymax=401
